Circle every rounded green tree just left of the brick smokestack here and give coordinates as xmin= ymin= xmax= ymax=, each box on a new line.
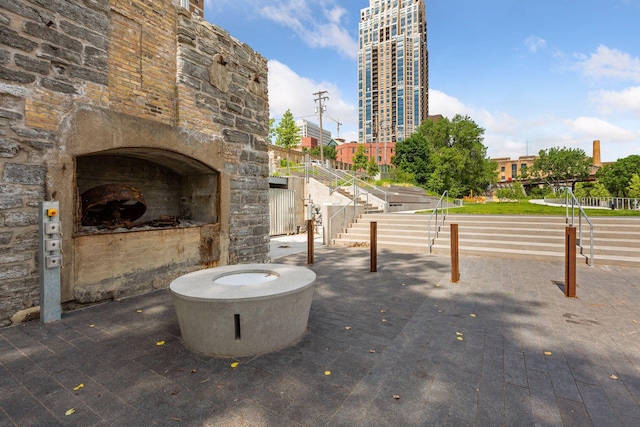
xmin=526 ymin=147 xmax=593 ymax=189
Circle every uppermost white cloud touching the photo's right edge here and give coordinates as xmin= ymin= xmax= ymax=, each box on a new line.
xmin=576 ymin=45 xmax=640 ymax=82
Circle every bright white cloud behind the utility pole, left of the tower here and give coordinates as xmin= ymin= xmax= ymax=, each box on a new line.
xmin=268 ymin=60 xmax=358 ymax=141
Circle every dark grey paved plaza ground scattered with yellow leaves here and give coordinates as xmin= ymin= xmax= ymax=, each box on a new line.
xmin=0 ymin=247 xmax=640 ymax=427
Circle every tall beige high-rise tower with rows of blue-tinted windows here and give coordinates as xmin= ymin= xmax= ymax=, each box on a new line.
xmin=358 ymin=0 xmax=429 ymax=143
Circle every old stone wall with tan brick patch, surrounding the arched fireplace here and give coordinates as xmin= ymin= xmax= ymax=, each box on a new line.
xmin=0 ymin=0 xmax=269 ymax=326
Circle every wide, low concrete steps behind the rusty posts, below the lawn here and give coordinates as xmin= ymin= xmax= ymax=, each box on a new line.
xmin=333 ymin=214 xmax=640 ymax=268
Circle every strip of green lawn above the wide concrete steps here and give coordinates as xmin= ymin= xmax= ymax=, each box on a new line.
xmin=420 ymin=200 xmax=640 ymax=216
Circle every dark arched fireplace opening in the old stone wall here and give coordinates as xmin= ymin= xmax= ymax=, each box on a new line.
xmin=76 ymin=148 xmax=219 ymax=234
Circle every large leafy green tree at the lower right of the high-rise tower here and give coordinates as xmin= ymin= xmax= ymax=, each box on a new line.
xmin=391 ymin=115 xmax=497 ymax=197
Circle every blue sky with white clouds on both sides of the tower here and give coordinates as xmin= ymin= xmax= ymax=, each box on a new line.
xmin=205 ymin=0 xmax=640 ymax=162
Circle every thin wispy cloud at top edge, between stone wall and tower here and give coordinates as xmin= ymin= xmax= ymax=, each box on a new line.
xmin=259 ymin=0 xmax=358 ymax=59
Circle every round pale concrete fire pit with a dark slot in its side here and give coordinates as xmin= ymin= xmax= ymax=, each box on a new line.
xmin=169 ymin=264 xmax=316 ymax=357
